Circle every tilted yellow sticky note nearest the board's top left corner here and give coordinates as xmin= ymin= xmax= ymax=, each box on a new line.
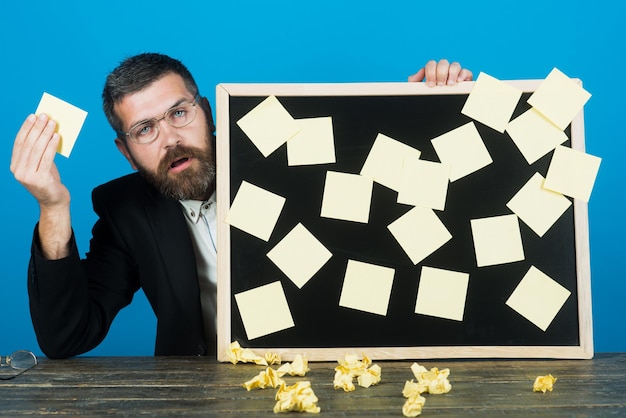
xmin=237 ymin=96 xmax=300 ymax=157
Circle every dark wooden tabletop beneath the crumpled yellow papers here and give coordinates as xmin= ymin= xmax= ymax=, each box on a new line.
xmin=0 ymin=353 xmax=626 ymax=418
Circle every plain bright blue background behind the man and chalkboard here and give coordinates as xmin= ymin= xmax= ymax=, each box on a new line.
xmin=0 ymin=0 xmax=626 ymax=355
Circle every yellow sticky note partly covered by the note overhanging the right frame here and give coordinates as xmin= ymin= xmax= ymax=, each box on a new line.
xmin=506 ymin=173 xmax=572 ymax=237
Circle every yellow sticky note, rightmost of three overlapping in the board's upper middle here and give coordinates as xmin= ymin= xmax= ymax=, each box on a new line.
xmin=431 ymin=122 xmax=493 ymax=181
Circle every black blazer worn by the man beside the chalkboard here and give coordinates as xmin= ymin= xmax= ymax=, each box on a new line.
xmin=28 ymin=173 xmax=216 ymax=358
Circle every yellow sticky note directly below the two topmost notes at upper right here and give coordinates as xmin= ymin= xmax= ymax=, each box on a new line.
xmin=506 ymin=108 xmax=567 ymax=164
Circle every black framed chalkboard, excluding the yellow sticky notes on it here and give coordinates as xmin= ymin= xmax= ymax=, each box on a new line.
xmin=216 ymin=80 xmax=593 ymax=361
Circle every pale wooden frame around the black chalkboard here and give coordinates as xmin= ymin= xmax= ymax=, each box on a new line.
xmin=216 ymin=80 xmax=593 ymax=361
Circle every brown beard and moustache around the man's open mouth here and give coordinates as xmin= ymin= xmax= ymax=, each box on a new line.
xmin=135 ymin=140 xmax=215 ymax=200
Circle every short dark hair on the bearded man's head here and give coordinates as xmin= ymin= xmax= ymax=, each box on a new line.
xmin=102 ymin=53 xmax=198 ymax=136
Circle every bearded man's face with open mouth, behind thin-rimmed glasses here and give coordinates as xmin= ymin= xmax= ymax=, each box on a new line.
xmin=114 ymin=74 xmax=215 ymax=200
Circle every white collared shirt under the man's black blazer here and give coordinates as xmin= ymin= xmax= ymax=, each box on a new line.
xmin=180 ymin=192 xmax=217 ymax=339
